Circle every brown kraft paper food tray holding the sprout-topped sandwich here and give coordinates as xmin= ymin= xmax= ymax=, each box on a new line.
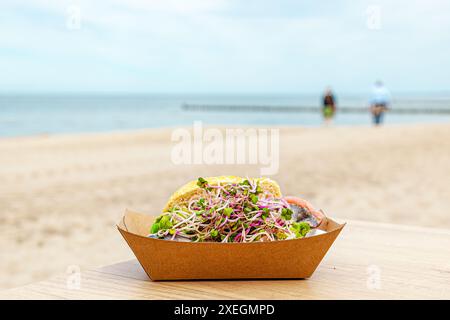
xmin=117 ymin=210 xmax=345 ymax=280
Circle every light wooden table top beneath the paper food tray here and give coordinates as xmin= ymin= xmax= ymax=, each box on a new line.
xmin=0 ymin=221 xmax=450 ymax=299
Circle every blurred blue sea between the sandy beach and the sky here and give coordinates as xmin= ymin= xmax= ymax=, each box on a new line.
xmin=0 ymin=93 xmax=450 ymax=137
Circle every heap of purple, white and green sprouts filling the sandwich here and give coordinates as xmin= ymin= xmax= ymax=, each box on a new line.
xmin=149 ymin=178 xmax=309 ymax=242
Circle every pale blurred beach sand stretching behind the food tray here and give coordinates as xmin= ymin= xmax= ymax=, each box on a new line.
xmin=0 ymin=124 xmax=450 ymax=288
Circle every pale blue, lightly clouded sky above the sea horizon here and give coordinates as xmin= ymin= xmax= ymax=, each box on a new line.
xmin=0 ymin=0 xmax=450 ymax=94
